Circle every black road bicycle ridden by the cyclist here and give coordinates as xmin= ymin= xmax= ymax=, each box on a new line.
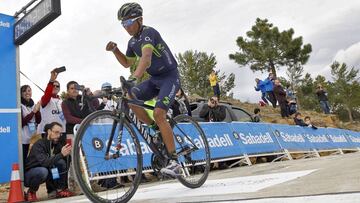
xmin=72 ymin=76 xmax=210 ymax=203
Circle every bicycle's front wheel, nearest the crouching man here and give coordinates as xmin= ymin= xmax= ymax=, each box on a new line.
xmin=72 ymin=110 xmax=142 ymax=203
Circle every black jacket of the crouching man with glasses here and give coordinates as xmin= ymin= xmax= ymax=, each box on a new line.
xmin=25 ymin=137 xmax=65 ymax=171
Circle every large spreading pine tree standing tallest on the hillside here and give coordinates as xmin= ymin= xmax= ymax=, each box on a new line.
xmin=229 ymin=18 xmax=312 ymax=76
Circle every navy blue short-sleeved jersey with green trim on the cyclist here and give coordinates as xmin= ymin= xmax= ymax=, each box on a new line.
xmin=126 ymin=26 xmax=177 ymax=76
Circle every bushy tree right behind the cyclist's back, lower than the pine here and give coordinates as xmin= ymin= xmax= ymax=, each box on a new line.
xmin=176 ymin=50 xmax=235 ymax=97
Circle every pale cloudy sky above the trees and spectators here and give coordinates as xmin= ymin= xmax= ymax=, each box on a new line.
xmin=0 ymin=0 xmax=360 ymax=102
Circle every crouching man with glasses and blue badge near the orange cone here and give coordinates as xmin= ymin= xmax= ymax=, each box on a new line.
xmin=24 ymin=122 xmax=73 ymax=202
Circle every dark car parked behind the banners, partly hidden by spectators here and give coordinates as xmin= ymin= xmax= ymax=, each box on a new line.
xmin=190 ymin=99 xmax=253 ymax=122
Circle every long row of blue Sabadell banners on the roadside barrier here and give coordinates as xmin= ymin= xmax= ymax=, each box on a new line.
xmin=83 ymin=122 xmax=360 ymax=176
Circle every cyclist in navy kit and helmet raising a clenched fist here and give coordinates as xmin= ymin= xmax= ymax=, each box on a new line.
xmin=106 ymin=3 xmax=180 ymax=178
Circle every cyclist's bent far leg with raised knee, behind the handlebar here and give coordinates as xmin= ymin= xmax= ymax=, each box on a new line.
xmin=129 ymin=79 xmax=159 ymax=125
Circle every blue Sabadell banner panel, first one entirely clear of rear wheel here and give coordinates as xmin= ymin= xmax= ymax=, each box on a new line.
xmin=231 ymin=122 xmax=281 ymax=154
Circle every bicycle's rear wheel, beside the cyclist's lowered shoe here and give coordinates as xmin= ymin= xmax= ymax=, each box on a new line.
xmin=173 ymin=115 xmax=210 ymax=188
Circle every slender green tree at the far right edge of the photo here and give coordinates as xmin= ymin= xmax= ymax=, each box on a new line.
xmin=330 ymin=61 xmax=360 ymax=122
